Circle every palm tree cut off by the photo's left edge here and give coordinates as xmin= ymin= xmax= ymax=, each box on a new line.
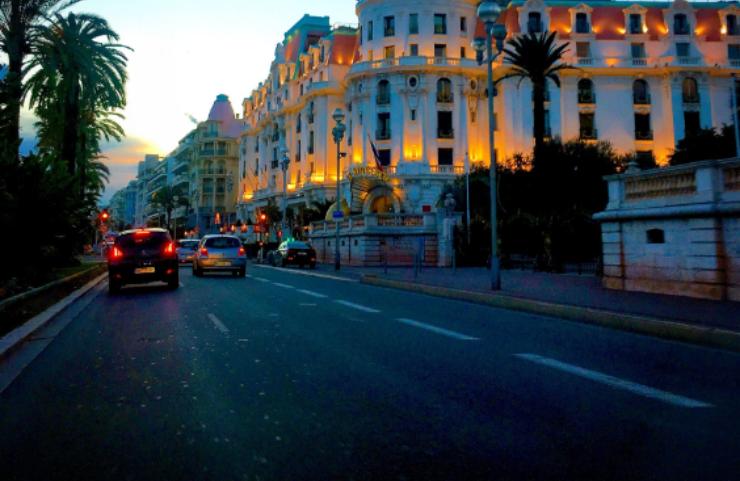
xmin=0 ymin=0 xmax=81 ymax=160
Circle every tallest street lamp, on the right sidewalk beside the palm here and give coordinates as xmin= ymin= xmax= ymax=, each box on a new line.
xmin=473 ymin=0 xmax=506 ymax=291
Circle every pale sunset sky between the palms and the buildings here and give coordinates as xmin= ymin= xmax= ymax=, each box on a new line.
xmin=14 ymin=0 xmax=357 ymax=203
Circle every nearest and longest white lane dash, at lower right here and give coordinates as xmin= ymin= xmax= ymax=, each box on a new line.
xmin=514 ymin=353 xmax=713 ymax=408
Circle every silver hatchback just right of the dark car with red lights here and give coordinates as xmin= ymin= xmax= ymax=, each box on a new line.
xmin=193 ymin=235 xmax=247 ymax=277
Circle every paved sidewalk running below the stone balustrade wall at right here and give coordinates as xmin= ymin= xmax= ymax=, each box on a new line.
xmin=322 ymin=266 xmax=740 ymax=333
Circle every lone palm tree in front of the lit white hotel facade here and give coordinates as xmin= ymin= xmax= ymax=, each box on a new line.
xmin=499 ymin=32 xmax=573 ymax=157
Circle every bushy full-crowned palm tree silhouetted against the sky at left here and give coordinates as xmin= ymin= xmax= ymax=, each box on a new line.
xmin=26 ymin=13 xmax=129 ymax=180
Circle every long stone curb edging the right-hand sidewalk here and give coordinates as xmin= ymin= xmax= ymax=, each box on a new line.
xmin=360 ymin=275 xmax=740 ymax=352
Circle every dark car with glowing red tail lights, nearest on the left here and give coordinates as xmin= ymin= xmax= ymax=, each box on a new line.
xmin=108 ymin=229 xmax=180 ymax=294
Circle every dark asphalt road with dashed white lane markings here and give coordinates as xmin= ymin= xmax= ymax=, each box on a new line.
xmin=0 ymin=266 xmax=740 ymax=481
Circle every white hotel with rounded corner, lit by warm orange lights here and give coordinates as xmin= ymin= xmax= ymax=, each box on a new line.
xmin=238 ymin=0 xmax=740 ymax=262
